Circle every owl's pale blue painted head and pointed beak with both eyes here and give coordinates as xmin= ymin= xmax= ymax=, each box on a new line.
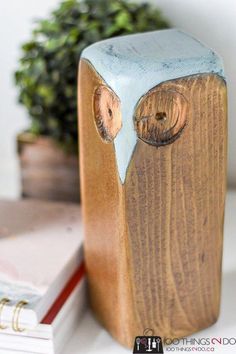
xmin=82 ymin=30 xmax=222 ymax=183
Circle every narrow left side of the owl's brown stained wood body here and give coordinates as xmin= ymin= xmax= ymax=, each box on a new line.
xmin=79 ymin=60 xmax=133 ymax=344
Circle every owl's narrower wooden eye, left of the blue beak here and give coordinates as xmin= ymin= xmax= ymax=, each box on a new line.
xmin=94 ymin=85 xmax=122 ymax=143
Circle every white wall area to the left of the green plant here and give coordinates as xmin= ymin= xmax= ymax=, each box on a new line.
xmin=0 ymin=0 xmax=58 ymax=198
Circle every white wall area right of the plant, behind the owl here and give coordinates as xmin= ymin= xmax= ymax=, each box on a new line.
xmin=155 ymin=0 xmax=236 ymax=187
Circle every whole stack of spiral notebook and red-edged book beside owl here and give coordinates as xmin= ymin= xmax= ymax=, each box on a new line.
xmin=0 ymin=200 xmax=86 ymax=354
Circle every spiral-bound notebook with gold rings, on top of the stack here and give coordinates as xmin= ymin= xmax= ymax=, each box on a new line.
xmin=0 ymin=200 xmax=82 ymax=333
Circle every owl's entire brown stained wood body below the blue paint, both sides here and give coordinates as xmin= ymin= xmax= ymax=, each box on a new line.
xmin=79 ymin=60 xmax=227 ymax=347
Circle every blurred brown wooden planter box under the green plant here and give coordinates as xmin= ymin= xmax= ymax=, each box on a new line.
xmin=17 ymin=133 xmax=80 ymax=203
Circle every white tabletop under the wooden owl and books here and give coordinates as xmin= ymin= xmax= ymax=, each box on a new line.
xmin=63 ymin=191 xmax=236 ymax=354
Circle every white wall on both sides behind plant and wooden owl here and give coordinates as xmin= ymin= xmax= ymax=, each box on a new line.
xmin=0 ymin=0 xmax=236 ymax=198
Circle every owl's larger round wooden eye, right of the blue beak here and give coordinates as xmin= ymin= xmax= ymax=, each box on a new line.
xmin=134 ymin=88 xmax=187 ymax=146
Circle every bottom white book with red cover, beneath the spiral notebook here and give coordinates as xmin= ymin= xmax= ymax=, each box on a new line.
xmin=0 ymin=271 xmax=87 ymax=354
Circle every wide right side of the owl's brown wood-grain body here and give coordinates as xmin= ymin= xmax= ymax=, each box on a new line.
xmin=125 ymin=75 xmax=227 ymax=337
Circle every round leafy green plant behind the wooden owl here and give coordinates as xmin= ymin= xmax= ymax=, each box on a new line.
xmin=15 ymin=0 xmax=168 ymax=152
